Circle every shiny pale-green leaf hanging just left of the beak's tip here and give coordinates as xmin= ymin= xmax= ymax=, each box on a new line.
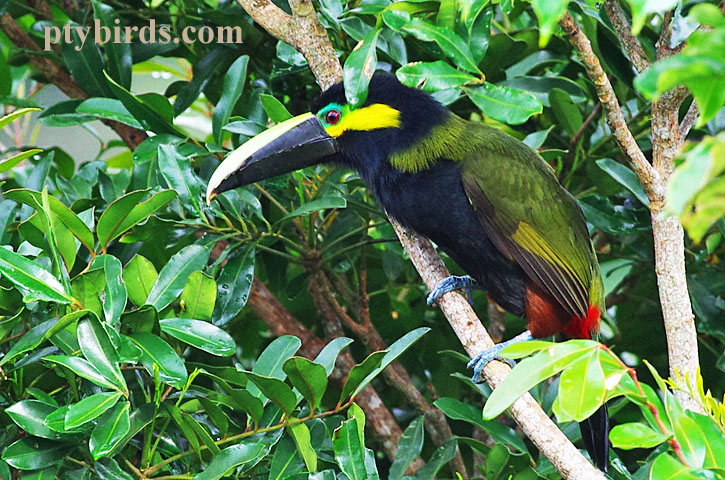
xmin=158 ymin=144 xmax=201 ymax=215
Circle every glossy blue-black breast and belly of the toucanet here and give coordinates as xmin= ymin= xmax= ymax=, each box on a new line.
xmin=366 ymin=161 xmax=526 ymax=316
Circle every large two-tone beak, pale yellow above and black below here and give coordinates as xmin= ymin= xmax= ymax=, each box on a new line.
xmin=206 ymin=113 xmax=338 ymax=205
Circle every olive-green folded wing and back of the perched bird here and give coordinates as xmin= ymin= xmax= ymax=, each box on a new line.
xmin=459 ymin=126 xmax=604 ymax=316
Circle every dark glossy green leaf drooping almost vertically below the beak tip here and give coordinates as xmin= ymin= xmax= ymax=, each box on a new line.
xmin=212 ymin=245 xmax=255 ymax=325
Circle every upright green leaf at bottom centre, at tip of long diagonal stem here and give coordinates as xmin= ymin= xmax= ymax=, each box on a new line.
xmin=332 ymin=404 xmax=374 ymax=480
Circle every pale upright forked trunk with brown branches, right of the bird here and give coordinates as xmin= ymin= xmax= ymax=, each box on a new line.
xmin=559 ymin=6 xmax=701 ymax=411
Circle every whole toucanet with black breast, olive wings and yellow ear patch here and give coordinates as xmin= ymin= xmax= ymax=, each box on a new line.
xmin=207 ymin=73 xmax=609 ymax=470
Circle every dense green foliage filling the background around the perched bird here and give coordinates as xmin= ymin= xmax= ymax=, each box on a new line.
xmin=0 ymin=1 xmax=725 ymax=478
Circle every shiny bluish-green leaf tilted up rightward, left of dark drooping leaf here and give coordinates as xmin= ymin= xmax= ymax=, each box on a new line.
xmin=146 ymin=245 xmax=209 ymax=311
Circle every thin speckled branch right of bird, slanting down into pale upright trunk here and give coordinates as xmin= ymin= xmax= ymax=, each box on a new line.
xmin=559 ymin=13 xmax=664 ymax=201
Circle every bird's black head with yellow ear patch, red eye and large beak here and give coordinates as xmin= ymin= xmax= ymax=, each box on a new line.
xmin=206 ymin=73 xmax=449 ymax=203
